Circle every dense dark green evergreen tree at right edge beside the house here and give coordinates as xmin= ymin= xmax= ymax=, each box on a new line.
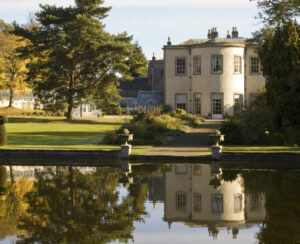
xmin=256 ymin=21 xmax=300 ymax=141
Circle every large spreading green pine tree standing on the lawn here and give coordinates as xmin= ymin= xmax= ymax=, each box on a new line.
xmin=15 ymin=0 xmax=146 ymax=119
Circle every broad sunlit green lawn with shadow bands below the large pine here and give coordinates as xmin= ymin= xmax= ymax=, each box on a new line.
xmin=1 ymin=117 xmax=125 ymax=150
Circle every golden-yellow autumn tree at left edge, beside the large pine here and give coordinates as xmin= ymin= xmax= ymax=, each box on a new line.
xmin=0 ymin=20 xmax=28 ymax=107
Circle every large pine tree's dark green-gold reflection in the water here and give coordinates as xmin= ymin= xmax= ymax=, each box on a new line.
xmin=20 ymin=167 xmax=147 ymax=243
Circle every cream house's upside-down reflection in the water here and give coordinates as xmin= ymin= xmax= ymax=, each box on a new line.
xmin=164 ymin=164 xmax=266 ymax=239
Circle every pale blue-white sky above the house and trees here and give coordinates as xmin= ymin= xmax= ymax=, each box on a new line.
xmin=0 ymin=0 xmax=261 ymax=59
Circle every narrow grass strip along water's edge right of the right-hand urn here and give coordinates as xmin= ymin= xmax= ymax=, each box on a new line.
xmin=223 ymin=146 xmax=300 ymax=153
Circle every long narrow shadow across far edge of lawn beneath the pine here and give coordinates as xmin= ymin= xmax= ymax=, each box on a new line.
xmin=8 ymin=117 xmax=123 ymax=125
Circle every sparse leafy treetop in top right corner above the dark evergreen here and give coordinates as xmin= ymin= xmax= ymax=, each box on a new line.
xmin=250 ymin=0 xmax=300 ymax=25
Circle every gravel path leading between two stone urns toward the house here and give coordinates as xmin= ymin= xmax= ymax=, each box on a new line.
xmin=143 ymin=120 xmax=222 ymax=156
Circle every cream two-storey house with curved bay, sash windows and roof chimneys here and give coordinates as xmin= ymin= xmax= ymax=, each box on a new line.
xmin=160 ymin=27 xmax=265 ymax=119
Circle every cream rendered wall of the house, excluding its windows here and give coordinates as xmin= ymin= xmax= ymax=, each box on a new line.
xmin=164 ymin=44 xmax=265 ymax=116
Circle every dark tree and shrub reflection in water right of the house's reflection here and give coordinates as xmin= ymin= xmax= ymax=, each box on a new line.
xmin=222 ymin=169 xmax=300 ymax=244
